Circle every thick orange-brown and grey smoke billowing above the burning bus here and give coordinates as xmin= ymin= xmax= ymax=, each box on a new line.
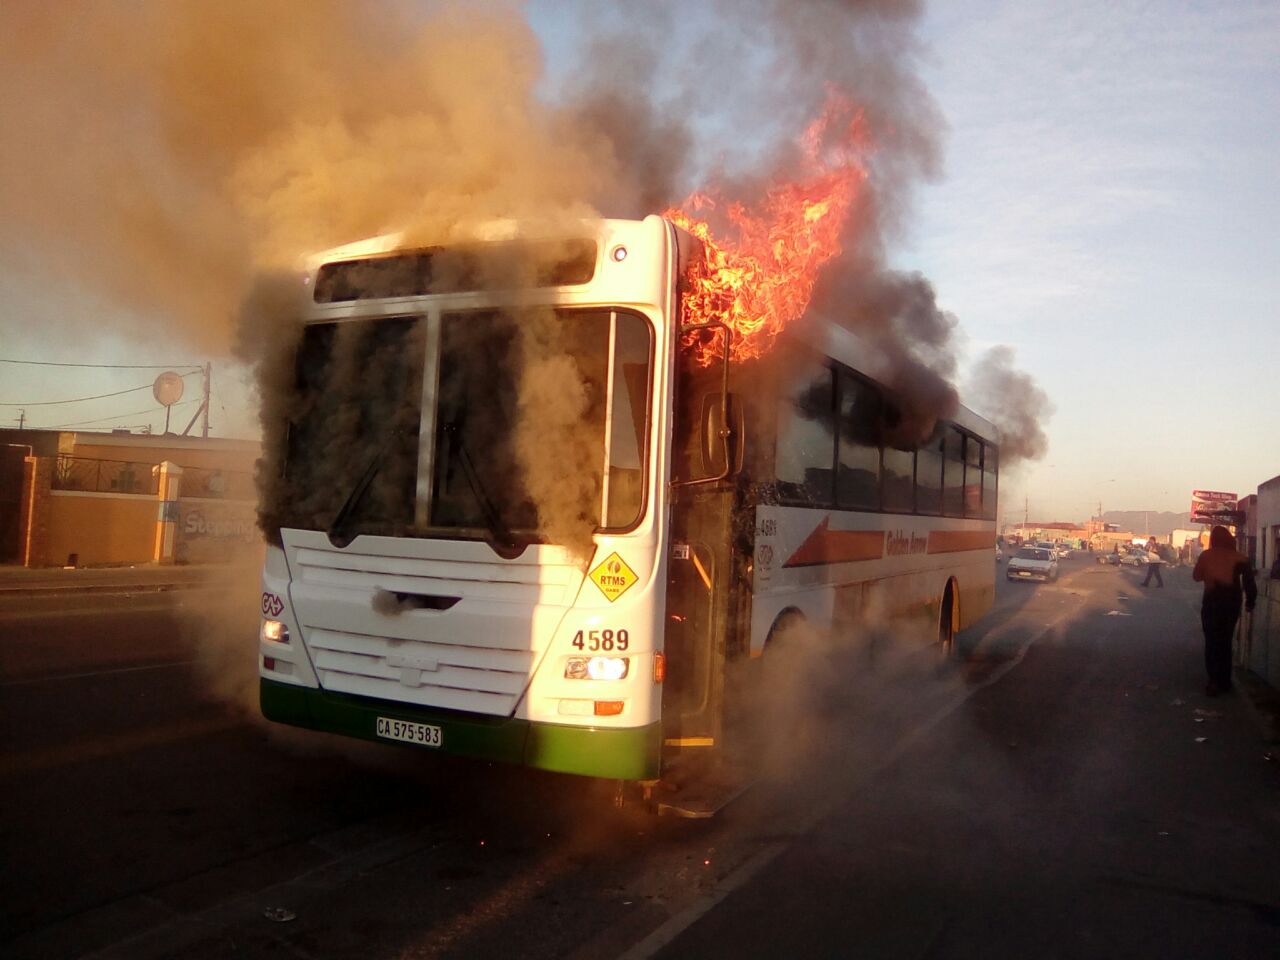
xmin=0 ymin=0 xmax=1049 ymax=488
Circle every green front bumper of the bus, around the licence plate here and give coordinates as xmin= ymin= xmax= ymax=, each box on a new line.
xmin=259 ymin=678 xmax=662 ymax=780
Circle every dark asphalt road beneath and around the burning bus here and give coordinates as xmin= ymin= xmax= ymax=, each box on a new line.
xmin=0 ymin=561 xmax=1280 ymax=959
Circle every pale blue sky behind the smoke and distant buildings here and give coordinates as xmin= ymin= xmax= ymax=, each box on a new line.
xmin=0 ymin=0 xmax=1280 ymax=521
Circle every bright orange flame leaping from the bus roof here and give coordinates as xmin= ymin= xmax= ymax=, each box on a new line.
xmin=666 ymin=91 xmax=869 ymax=366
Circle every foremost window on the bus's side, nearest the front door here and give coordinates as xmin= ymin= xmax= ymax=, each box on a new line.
xmin=774 ymin=362 xmax=836 ymax=506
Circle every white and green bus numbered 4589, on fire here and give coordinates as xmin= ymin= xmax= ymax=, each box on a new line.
xmin=259 ymin=216 xmax=997 ymax=798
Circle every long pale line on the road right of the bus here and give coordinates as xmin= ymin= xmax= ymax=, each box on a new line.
xmin=618 ymin=609 xmax=1075 ymax=960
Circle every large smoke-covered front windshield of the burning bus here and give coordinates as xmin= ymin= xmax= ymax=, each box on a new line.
xmin=280 ymin=308 xmax=652 ymax=541
